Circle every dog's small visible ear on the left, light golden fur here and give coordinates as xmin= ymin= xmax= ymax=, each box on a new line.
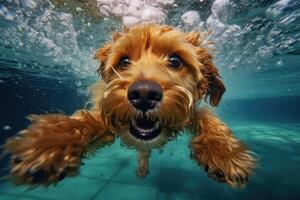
xmin=94 ymin=43 xmax=112 ymax=80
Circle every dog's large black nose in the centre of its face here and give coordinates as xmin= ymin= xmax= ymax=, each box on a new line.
xmin=127 ymin=80 xmax=162 ymax=112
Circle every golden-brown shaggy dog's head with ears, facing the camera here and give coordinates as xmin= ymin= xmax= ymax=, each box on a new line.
xmin=95 ymin=24 xmax=225 ymax=149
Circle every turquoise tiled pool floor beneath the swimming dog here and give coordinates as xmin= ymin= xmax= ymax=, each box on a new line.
xmin=0 ymin=122 xmax=300 ymax=200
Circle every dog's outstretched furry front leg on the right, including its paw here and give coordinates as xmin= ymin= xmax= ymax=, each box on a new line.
xmin=190 ymin=110 xmax=255 ymax=187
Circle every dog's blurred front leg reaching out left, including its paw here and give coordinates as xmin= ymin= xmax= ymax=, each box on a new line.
xmin=4 ymin=110 xmax=114 ymax=185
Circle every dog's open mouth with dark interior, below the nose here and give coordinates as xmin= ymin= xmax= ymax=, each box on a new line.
xmin=130 ymin=116 xmax=161 ymax=140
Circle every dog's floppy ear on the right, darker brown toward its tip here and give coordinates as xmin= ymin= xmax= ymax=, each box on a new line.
xmin=185 ymin=32 xmax=226 ymax=106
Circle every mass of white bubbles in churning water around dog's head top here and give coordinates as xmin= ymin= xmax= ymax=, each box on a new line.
xmin=0 ymin=0 xmax=300 ymax=98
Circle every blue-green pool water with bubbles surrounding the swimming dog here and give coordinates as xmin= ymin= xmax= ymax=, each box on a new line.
xmin=0 ymin=0 xmax=300 ymax=200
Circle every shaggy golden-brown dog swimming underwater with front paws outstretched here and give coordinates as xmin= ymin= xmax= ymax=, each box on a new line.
xmin=4 ymin=24 xmax=256 ymax=187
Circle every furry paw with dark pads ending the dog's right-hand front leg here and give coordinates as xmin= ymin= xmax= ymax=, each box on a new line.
xmin=205 ymin=151 xmax=255 ymax=187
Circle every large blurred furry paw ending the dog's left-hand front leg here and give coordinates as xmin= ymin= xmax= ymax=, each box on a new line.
xmin=4 ymin=115 xmax=84 ymax=185
